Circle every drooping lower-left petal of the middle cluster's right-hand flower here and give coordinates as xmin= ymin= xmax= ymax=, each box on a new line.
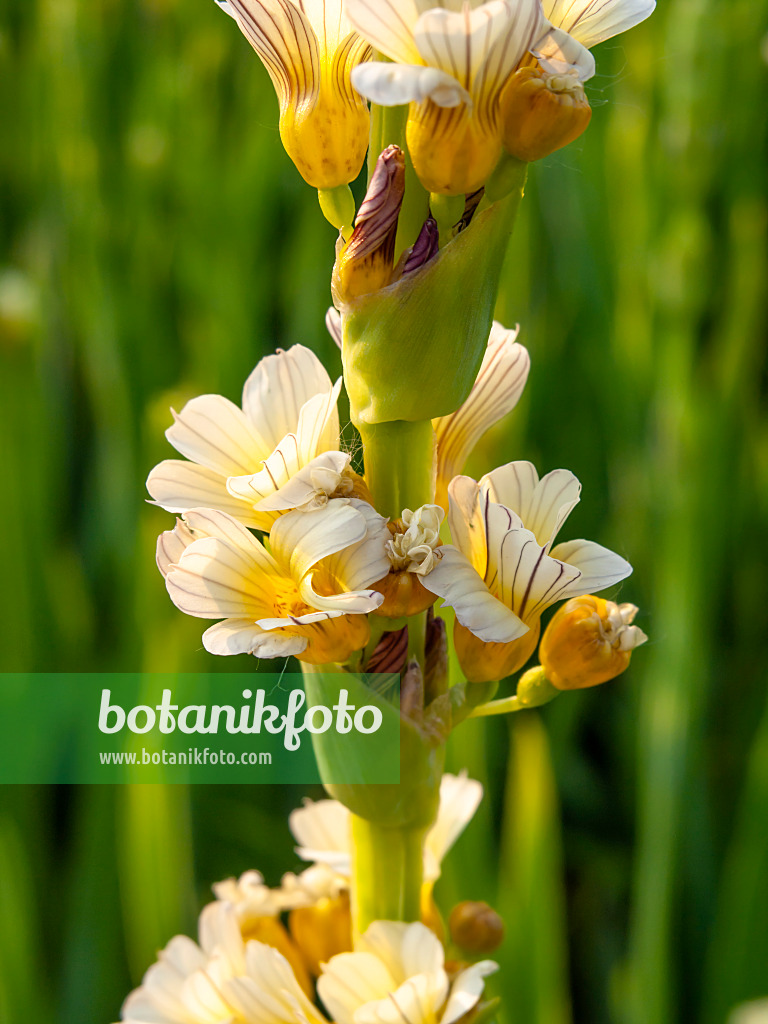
xmin=422 ymin=546 xmax=528 ymax=643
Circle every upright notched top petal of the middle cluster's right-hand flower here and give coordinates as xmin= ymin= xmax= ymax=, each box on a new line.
xmin=480 ymin=462 xmax=582 ymax=549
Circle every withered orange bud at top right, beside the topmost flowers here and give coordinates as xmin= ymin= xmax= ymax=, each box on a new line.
xmin=501 ymin=68 xmax=592 ymax=162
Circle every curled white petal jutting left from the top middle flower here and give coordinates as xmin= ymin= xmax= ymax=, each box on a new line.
xmin=351 ymin=60 xmax=471 ymax=106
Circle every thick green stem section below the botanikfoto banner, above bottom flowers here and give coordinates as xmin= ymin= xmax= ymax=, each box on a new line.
xmin=352 ymin=814 xmax=426 ymax=936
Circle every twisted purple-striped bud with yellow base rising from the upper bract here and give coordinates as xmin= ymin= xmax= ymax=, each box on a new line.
xmin=334 ymin=145 xmax=406 ymax=302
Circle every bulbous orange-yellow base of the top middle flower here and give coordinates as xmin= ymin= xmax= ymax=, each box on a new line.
xmin=406 ymin=99 xmax=502 ymax=196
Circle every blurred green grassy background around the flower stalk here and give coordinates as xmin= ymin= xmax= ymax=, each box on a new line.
xmin=0 ymin=0 xmax=768 ymax=1024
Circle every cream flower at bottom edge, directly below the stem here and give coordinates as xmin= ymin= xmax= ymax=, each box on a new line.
xmin=317 ymin=921 xmax=498 ymax=1024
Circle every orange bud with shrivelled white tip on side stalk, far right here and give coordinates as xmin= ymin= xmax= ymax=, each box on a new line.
xmin=539 ymin=594 xmax=648 ymax=690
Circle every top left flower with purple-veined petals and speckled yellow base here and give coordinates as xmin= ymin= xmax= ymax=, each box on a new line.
xmin=217 ymin=0 xmax=371 ymax=189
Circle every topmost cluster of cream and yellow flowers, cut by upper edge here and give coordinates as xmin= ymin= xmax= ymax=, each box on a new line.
xmin=217 ymin=0 xmax=655 ymax=196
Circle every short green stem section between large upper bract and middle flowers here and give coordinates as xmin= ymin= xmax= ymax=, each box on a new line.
xmin=357 ymin=420 xmax=435 ymax=519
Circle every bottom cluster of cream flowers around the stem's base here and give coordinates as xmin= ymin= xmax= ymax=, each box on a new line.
xmin=122 ymin=775 xmax=496 ymax=1024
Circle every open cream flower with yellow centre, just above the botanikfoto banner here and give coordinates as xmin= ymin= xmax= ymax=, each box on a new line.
xmin=158 ymin=499 xmax=389 ymax=664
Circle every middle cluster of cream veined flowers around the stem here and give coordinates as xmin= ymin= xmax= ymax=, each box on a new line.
xmin=147 ymin=323 xmax=643 ymax=682
